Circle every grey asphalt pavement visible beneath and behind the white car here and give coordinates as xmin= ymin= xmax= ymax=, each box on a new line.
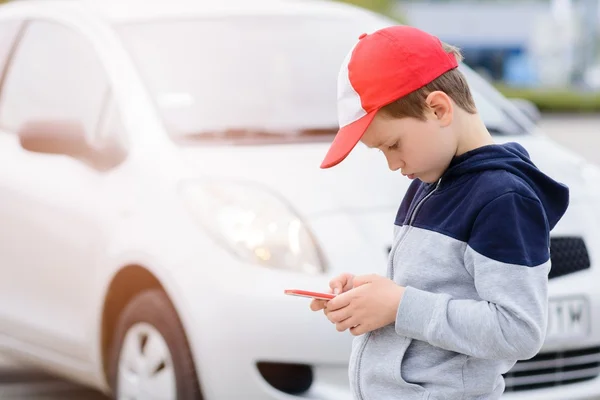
xmin=0 ymin=114 xmax=600 ymax=400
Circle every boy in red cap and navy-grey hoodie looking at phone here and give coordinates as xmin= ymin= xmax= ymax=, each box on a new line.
xmin=311 ymin=26 xmax=569 ymax=400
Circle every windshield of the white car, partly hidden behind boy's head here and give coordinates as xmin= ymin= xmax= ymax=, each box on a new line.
xmin=117 ymin=15 xmax=523 ymax=141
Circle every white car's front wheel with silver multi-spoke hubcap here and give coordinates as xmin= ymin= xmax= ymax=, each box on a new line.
xmin=109 ymin=289 xmax=202 ymax=400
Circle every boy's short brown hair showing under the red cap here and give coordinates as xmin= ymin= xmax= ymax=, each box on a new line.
xmin=381 ymin=43 xmax=477 ymax=120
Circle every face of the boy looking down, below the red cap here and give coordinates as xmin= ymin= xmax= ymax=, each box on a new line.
xmin=361 ymin=111 xmax=457 ymax=183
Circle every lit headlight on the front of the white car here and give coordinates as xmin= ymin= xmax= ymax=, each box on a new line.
xmin=181 ymin=181 xmax=324 ymax=274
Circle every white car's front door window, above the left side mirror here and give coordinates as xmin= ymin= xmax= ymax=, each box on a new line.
xmin=0 ymin=21 xmax=109 ymax=142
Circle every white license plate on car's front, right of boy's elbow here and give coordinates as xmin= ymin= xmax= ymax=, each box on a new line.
xmin=546 ymin=297 xmax=591 ymax=341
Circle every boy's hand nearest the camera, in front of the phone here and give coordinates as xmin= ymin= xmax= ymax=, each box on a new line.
xmin=325 ymin=275 xmax=404 ymax=336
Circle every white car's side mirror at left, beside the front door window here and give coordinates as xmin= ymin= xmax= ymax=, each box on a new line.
xmin=18 ymin=121 xmax=91 ymax=157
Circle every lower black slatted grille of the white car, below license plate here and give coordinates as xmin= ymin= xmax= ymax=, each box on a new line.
xmin=504 ymin=347 xmax=600 ymax=392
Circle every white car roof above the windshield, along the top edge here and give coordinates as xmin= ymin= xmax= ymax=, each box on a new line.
xmin=0 ymin=0 xmax=383 ymax=23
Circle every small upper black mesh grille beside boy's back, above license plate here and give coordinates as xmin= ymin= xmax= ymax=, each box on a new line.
xmin=548 ymin=237 xmax=591 ymax=279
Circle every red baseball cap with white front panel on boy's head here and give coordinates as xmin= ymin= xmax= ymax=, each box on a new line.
xmin=321 ymin=26 xmax=458 ymax=168
